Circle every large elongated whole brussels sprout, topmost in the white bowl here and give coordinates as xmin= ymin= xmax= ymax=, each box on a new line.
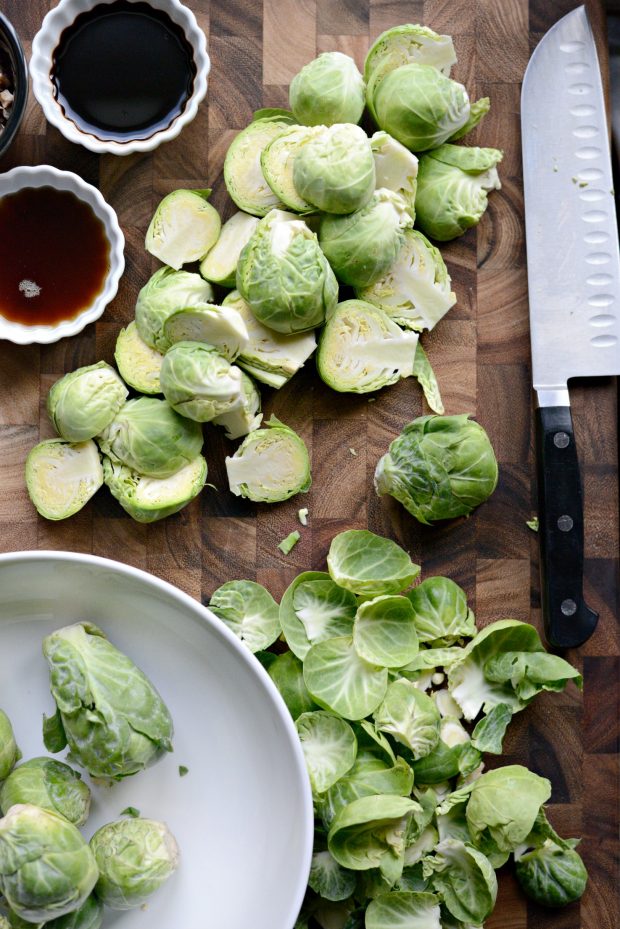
xmin=43 ymin=623 xmax=173 ymax=780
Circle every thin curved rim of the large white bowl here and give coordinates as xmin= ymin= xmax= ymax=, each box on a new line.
xmin=0 ymin=549 xmax=314 ymax=929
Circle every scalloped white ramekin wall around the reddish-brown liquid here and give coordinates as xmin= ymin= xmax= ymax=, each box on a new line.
xmin=0 ymin=165 xmax=125 ymax=345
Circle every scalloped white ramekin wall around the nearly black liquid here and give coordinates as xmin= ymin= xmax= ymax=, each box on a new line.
xmin=30 ymin=0 xmax=211 ymax=155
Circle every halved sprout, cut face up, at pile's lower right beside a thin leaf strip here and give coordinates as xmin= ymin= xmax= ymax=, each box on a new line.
xmin=317 ymin=300 xmax=418 ymax=394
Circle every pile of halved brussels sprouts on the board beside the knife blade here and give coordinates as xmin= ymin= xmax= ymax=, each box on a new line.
xmin=26 ymin=25 xmax=502 ymax=522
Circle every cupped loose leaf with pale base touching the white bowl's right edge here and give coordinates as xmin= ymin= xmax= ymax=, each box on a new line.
xmin=295 ymin=710 xmax=357 ymax=796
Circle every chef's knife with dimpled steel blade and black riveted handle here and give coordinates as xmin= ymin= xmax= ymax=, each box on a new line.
xmin=521 ymin=6 xmax=620 ymax=648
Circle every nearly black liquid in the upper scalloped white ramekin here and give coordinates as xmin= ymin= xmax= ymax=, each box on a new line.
xmin=51 ymin=0 xmax=196 ymax=142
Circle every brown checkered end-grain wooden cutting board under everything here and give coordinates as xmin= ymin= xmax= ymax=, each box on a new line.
xmin=0 ymin=0 xmax=620 ymax=929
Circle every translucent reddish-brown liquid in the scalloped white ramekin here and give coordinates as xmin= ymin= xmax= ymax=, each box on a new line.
xmin=0 ymin=187 xmax=110 ymax=326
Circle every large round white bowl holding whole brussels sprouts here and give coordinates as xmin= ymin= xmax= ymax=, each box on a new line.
xmin=0 ymin=552 xmax=313 ymax=929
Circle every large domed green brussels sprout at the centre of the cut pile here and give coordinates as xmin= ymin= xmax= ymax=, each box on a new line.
xmin=237 ymin=210 xmax=338 ymax=335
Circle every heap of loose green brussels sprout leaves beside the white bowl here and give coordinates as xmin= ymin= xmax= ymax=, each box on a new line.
xmin=210 ymin=530 xmax=587 ymax=929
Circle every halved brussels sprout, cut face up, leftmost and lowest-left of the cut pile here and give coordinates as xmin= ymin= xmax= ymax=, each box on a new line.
xmin=26 ymin=439 xmax=103 ymax=520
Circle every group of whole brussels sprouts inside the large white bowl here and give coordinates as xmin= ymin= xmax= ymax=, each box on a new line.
xmin=0 ymin=622 xmax=179 ymax=929
